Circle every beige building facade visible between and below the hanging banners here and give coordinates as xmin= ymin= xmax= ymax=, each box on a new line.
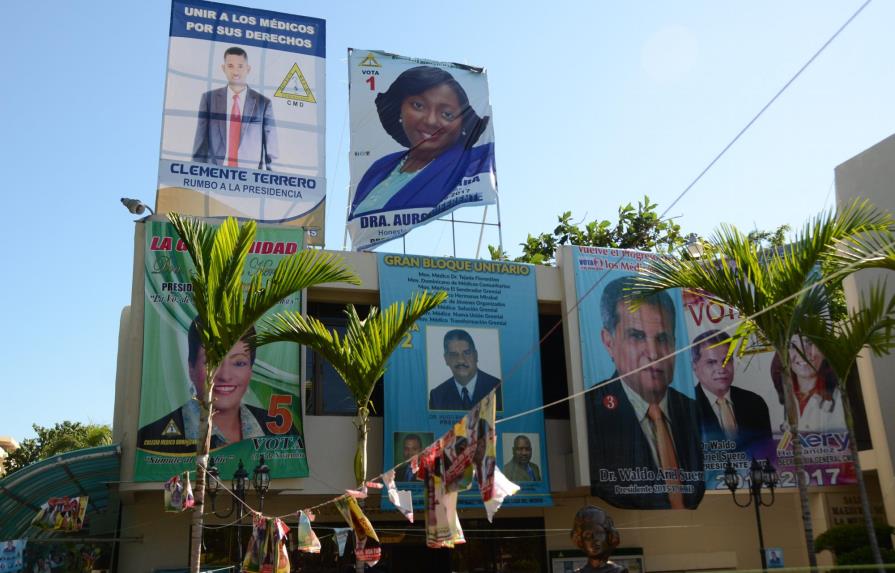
xmin=113 ymin=203 xmax=895 ymax=573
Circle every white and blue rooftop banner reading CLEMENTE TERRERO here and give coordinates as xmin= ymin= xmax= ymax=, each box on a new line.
xmin=156 ymin=0 xmax=326 ymax=244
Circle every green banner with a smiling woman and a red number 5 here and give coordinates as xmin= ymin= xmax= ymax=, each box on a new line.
xmin=134 ymin=221 xmax=308 ymax=481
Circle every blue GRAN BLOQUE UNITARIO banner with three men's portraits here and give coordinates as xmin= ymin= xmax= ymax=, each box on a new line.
xmin=378 ymin=254 xmax=552 ymax=506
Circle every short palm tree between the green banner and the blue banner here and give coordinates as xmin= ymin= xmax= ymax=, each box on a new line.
xmin=257 ymin=291 xmax=447 ymax=486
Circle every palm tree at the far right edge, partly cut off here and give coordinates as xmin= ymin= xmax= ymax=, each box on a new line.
xmin=801 ymin=281 xmax=895 ymax=573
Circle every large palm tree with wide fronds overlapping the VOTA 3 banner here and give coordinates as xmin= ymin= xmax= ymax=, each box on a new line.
xmin=630 ymin=201 xmax=893 ymax=569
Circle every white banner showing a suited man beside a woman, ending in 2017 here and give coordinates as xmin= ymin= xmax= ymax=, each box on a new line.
xmin=683 ymin=291 xmax=857 ymax=489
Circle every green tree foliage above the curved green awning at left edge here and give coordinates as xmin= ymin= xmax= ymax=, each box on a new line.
xmin=3 ymin=420 xmax=112 ymax=475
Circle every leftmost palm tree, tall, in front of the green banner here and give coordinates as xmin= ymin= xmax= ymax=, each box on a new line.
xmin=168 ymin=213 xmax=360 ymax=573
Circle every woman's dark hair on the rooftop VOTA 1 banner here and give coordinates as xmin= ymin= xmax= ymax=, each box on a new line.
xmin=376 ymin=66 xmax=489 ymax=148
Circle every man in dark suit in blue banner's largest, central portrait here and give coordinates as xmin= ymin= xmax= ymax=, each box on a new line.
xmin=429 ymin=328 xmax=503 ymax=411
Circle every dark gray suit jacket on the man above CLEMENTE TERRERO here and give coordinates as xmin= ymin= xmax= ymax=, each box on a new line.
xmin=193 ymin=86 xmax=278 ymax=170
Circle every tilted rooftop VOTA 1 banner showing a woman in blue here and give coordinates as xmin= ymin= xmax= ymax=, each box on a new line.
xmin=348 ymin=48 xmax=497 ymax=250
